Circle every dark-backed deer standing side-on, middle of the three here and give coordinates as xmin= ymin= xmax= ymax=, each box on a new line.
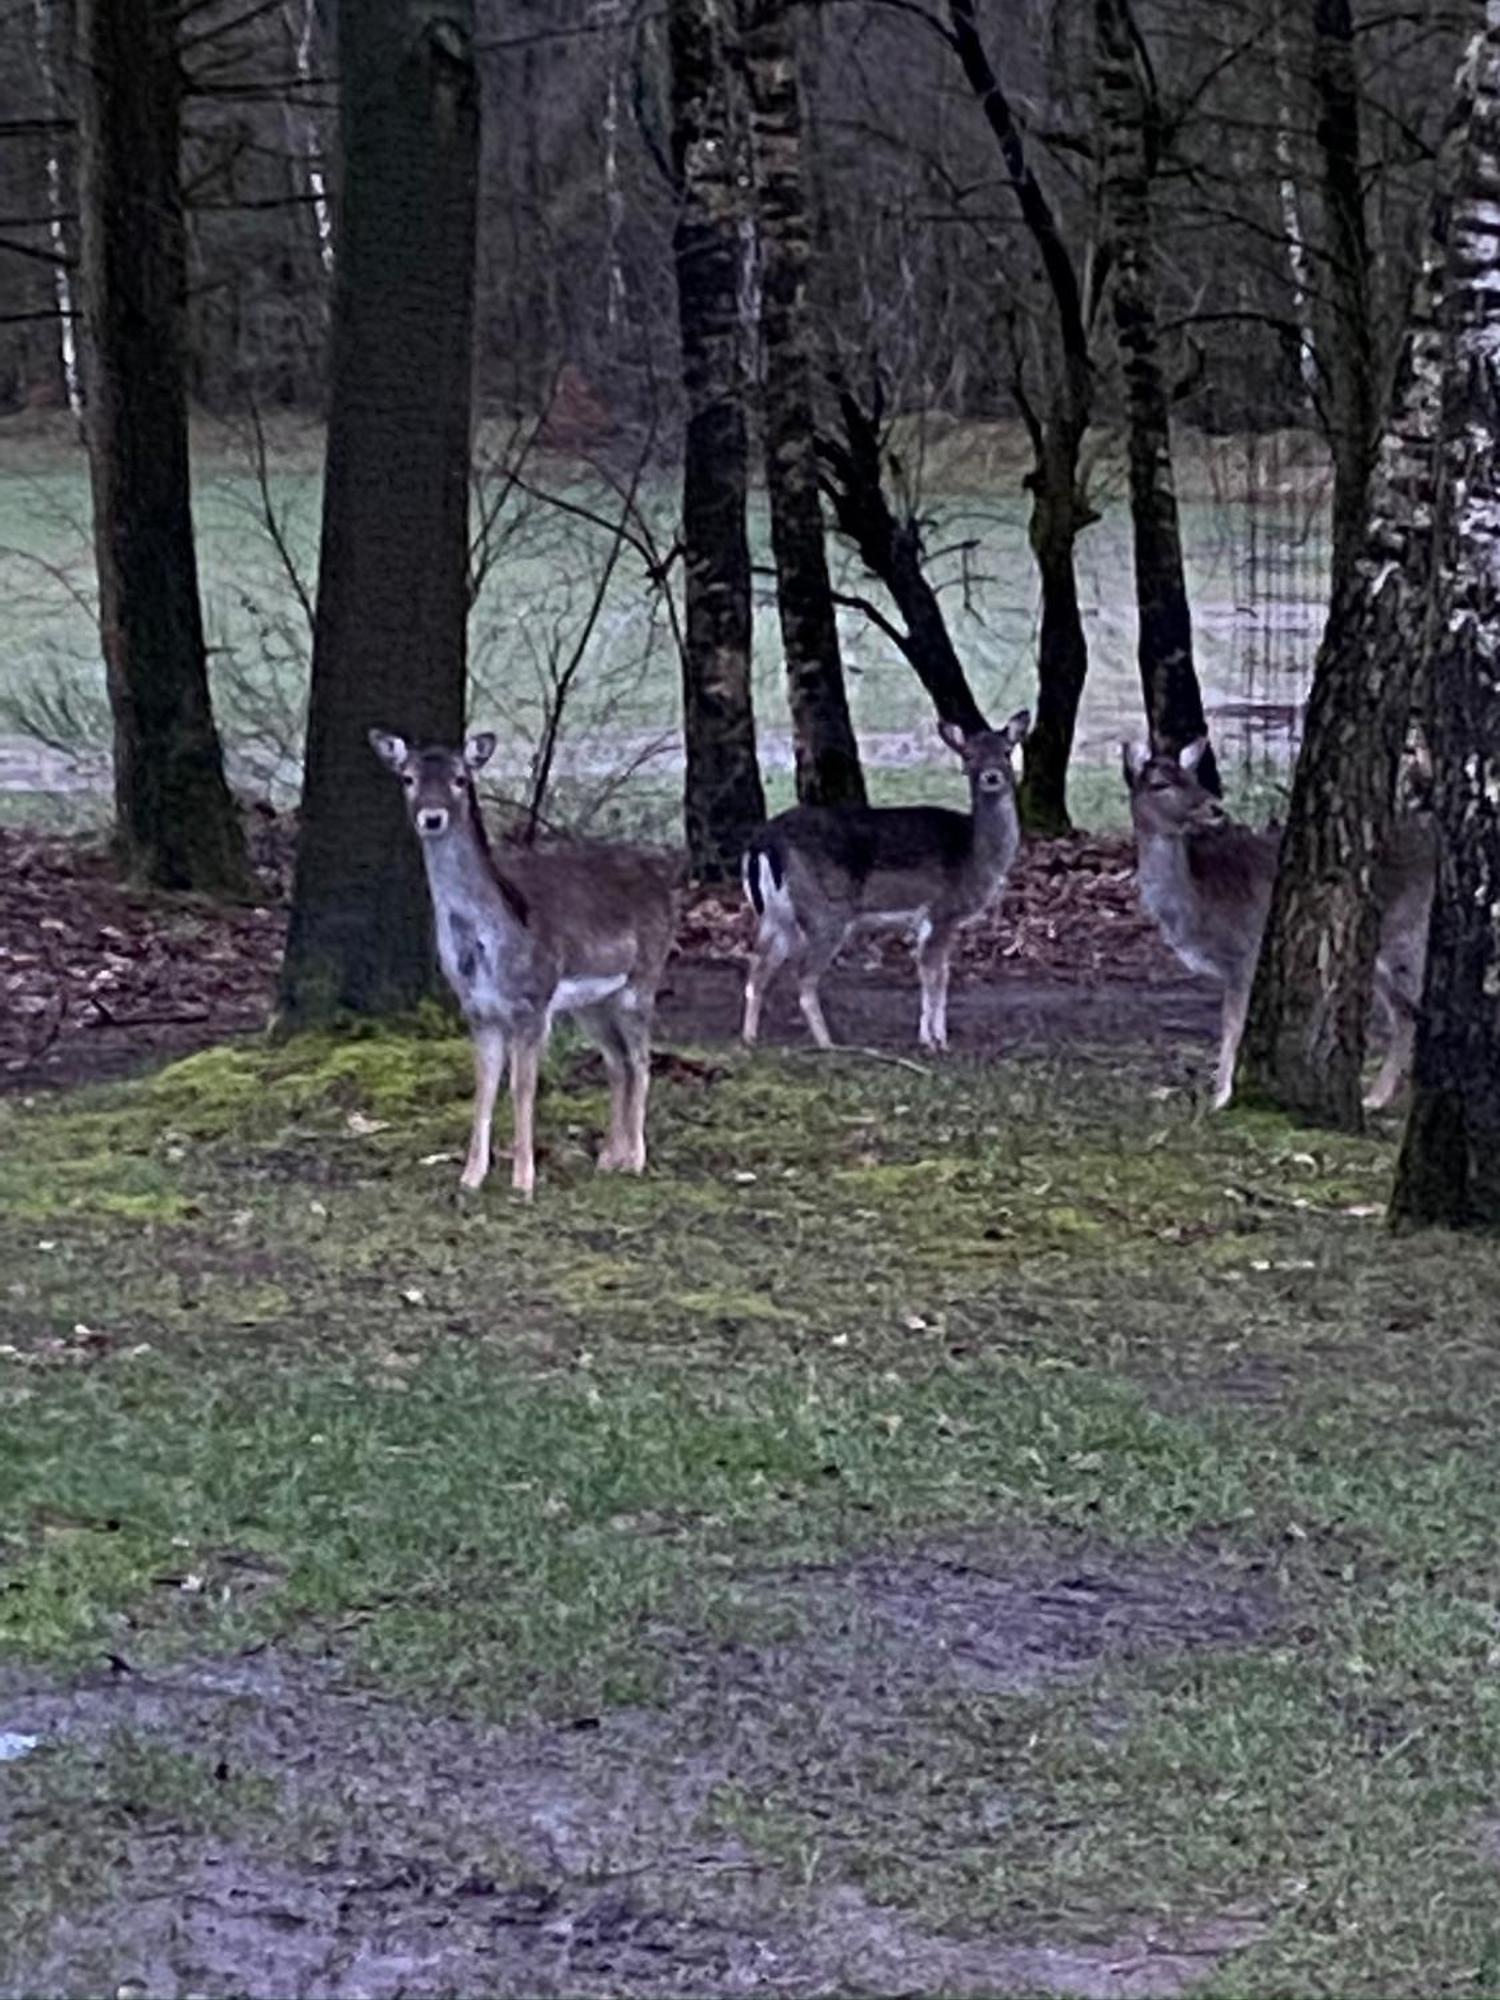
xmin=740 ymin=708 xmax=1032 ymax=1050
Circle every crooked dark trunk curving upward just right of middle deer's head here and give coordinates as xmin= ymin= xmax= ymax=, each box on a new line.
xmin=948 ymin=0 xmax=1098 ymax=834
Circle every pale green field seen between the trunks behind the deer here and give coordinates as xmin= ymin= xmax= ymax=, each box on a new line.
xmin=0 ymin=420 xmax=1324 ymax=828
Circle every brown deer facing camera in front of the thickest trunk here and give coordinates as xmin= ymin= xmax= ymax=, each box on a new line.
xmin=370 ymin=730 xmax=676 ymax=1200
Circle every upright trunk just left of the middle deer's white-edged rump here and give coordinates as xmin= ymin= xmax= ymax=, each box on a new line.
xmin=668 ymin=0 xmax=766 ymax=882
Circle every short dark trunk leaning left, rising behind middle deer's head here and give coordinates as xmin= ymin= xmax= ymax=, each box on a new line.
xmin=818 ymin=390 xmax=988 ymax=730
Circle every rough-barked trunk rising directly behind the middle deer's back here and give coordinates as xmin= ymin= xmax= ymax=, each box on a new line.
xmin=744 ymin=0 xmax=864 ymax=806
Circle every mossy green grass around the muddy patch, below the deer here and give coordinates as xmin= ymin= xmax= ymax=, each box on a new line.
xmin=0 ymin=1034 xmax=1500 ymax=1994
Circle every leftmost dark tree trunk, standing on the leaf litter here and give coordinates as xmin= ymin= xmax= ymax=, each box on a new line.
xmin=78 ymin=0 xmax=252 ymax=896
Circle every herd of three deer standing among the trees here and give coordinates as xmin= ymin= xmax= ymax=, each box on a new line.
xmin=370 ymin=710 xmax=1436 ymax=1194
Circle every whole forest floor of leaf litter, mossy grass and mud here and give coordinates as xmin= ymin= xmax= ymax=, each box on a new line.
xmin=0 ymin=828 xmax=1500 ymax=2000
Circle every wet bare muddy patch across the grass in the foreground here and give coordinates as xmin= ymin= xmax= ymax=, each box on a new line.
xmin=0 ymin=1538 xmax=1276 ymax=2000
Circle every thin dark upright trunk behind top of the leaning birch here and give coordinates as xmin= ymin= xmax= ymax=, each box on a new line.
xmin=1312 ymin=0 xmax=1380 ymax=602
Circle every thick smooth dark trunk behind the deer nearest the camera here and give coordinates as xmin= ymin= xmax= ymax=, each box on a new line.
xmin=280 ymin=0 xmax=478 ymax=1026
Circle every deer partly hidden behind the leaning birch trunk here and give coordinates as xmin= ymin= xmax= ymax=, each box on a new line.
xmin=1120 ymin=736 xmax=1436 ymax=1110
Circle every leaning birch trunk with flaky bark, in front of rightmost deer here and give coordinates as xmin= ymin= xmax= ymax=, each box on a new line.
xmin=1238 ymin=35 xmax=1474 ymax=1132
